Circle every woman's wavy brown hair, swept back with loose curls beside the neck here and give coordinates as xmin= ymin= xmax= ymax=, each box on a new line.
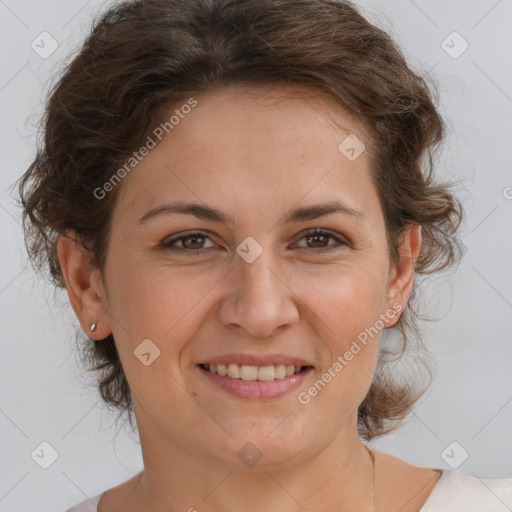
xmin=18 ymin=0 xmax=462 ymax=440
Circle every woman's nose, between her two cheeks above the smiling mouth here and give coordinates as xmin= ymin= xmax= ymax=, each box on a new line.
xmin=219 ymin=249 xmax=299 ymax=338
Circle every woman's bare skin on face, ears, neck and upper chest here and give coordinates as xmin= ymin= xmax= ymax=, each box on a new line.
xmin=59 ymin=86 xmax=439 ymax=512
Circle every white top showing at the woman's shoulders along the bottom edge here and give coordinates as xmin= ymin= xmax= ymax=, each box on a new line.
xmin=66 ymin=468 xmax=512 ymax=512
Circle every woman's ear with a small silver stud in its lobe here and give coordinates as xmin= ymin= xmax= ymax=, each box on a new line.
xmin=57 ymin=230 xmax=112 ymax=339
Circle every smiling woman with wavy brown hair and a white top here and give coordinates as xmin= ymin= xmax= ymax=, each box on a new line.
xmin=20 ymin=0 xmax=512 ymax=512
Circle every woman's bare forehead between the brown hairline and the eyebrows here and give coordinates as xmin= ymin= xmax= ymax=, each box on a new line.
xmin=111 ymin=85 xmax=371 ymax=226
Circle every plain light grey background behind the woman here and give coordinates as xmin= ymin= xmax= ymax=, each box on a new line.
xmin=0 ymin=0 xmax=512 ymax=512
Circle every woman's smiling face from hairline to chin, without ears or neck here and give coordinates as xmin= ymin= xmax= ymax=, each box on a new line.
xmin=81 ymin=87 xmax=407 ymax=467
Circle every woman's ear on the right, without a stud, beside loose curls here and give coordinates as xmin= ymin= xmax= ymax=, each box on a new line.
xmin=383 ymin=224 xmax=421 ymax=327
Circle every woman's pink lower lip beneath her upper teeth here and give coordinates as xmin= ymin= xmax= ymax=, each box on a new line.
xmin=197 ymin=366 xmax=313 ymax=400
